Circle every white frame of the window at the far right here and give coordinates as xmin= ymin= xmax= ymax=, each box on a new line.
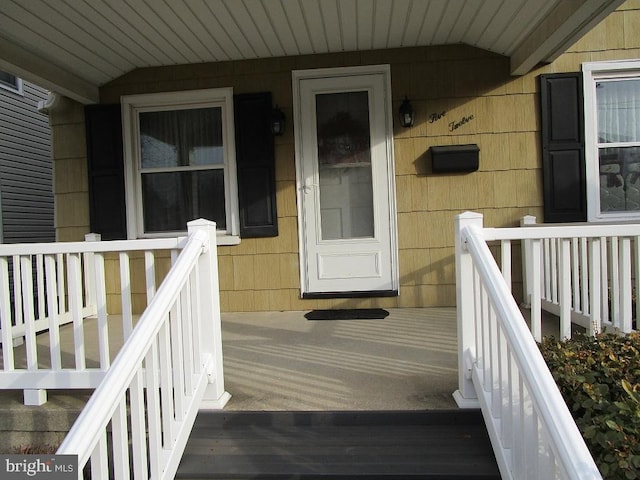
xmin=582 ymin=60 xmax=640 ymax=222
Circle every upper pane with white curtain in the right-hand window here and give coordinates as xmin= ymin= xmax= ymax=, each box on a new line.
xmin=596 ymin=79 xmax=640 ymax=143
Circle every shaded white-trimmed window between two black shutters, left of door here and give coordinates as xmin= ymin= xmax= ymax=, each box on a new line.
xmin=122 ymin=88 xmax=238 ymax=243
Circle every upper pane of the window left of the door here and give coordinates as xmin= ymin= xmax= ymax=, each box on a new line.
xmin=140 ymin=107 xmax=224 ymax=168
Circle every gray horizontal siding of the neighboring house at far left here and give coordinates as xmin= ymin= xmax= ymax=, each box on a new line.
xmin=0 ymin=82 xmax=55 ymax=243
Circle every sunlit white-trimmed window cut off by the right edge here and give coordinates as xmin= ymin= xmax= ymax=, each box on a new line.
xmin=583 ymin=61 xmax=640 ymax=221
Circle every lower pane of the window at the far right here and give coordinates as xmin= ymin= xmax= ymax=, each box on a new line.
xmin=599 ymin=147 xmax=640 ymax=212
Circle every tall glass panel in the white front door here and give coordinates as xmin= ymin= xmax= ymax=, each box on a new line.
xmin=316 ymin=91 xmax=374 ymax=240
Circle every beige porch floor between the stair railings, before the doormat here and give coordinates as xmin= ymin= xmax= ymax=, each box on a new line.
xmin=222 ymin=308 xmax=458 ymax=410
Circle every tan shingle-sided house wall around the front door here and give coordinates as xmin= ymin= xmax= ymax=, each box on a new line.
xmin=52 ymin=0 xmax=640 ymax=311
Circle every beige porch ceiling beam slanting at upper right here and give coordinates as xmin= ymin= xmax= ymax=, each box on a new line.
xmin=511 ymin=0 xmax=625 ymax=75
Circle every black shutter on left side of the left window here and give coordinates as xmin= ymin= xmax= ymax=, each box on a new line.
xmin=85 ymin=105 xmax=127 ymax=240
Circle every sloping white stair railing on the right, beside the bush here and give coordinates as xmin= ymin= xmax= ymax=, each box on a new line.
xmin=454 ymin=213 xmax=602 ymax=480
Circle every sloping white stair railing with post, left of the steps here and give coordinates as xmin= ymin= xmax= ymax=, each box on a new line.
xmin=57 ymin=221 xmax=229 ymax=480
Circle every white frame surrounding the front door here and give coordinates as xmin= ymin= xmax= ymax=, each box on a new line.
xmin=292 ymin=65 xmax=400 ymax=297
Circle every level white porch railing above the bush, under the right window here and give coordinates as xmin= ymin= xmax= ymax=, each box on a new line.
xmin=524 ymin=216 xmax=640 ymax=341
